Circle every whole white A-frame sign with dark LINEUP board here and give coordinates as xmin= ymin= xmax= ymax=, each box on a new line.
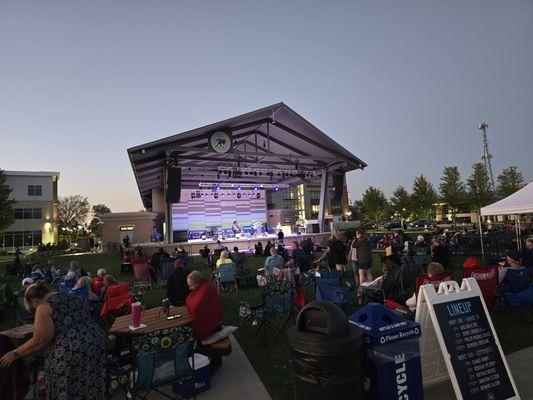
xmin=415 ymin=278 xmax=520 ymax=400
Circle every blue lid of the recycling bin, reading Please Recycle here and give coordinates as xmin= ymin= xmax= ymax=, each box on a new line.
xmin=348 ymin=303 xmax=420 ymax=345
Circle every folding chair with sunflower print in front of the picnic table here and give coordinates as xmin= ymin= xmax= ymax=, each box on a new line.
xmin=130 ymin=327 xmax=196 ymax=399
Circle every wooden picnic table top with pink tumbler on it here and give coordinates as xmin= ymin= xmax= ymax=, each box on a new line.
xmin=109 ymin=307 xmax=192 ymax=336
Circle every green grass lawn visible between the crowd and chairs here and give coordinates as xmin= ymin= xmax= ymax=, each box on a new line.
xmin=0 ymin=253 xmax=533 ymax=400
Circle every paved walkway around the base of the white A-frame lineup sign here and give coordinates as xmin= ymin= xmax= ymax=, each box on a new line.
xmin=424 ymin=347 xmax=533 ymax=400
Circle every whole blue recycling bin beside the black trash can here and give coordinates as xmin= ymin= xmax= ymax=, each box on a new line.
xmin=349 ymin=303 xmax=424 ymax=400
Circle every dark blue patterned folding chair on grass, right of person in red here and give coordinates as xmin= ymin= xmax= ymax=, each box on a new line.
xmin=250 ymin=281 xmax=296 ymax=346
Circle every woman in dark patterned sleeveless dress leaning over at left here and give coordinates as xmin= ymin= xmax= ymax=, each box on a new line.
xmin=0 ymin=282 xmax=106 ymax=400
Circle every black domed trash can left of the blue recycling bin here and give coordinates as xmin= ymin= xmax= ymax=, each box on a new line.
xmin=287 ymin=301 xmax=363 ymax=400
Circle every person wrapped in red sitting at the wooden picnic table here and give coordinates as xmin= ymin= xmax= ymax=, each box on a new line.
xmin=185 ymin=271 xmax=222 ymax=341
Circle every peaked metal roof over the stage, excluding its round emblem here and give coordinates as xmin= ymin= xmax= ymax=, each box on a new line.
xmin=128 ymin=103 xmax=366 ymax=208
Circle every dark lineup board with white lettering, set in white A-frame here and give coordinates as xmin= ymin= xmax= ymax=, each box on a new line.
xmin=433 ymin=296 xmax=516 ymax=400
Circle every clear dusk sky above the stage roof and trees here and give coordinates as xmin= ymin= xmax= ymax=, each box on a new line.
xmin=0 ymin=0 xmax=533 ymax=211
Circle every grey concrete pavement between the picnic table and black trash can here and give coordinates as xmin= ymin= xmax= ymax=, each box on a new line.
xmin=149 ymin=336 xmax=271 ymax=400
